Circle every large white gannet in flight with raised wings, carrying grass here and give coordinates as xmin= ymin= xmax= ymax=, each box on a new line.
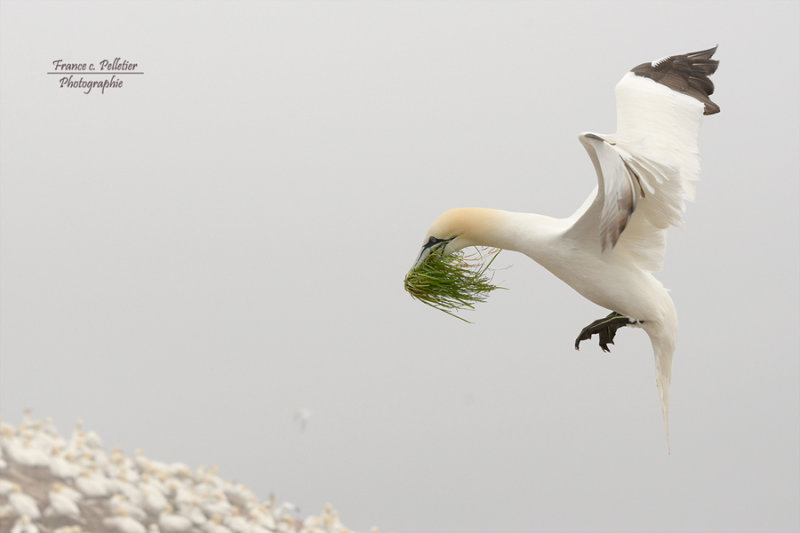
xmin=412 ymin=47 xmax=719 ymax=449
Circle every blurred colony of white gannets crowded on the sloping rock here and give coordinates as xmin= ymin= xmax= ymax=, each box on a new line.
xmin=0 ymin=412 xmax=377 ymax=533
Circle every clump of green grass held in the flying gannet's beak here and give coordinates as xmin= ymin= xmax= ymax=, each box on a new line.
xmin=405 ymin=249 xmax=504 ymax=322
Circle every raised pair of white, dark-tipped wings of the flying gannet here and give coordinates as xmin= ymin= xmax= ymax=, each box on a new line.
xmin=567 ymin=47 xmax=719 ymax=271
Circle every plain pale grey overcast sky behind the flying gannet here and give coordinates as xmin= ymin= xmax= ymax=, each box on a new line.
xmin=0 ymin=1 xmax=800 ymax=533
